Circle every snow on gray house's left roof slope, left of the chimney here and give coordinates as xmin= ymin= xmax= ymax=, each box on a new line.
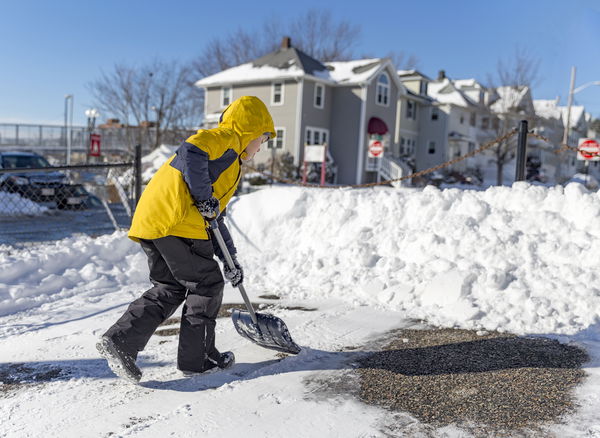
xmin=196 ymin=62 xmax=305 ymax=87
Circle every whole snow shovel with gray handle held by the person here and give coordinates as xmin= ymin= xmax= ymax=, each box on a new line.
xmin=209 ymin=219 xmax=301 ymax=354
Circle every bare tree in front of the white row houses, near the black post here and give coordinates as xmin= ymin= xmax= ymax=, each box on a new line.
xmin=488 ymin=47 xmax=540 ymax=185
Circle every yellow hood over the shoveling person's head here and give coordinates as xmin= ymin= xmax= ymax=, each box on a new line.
xmin=219 ymin=96 xmax=276 ymax=150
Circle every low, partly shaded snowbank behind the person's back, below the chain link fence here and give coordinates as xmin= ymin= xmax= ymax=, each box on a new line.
xmin=0 ymin=232 xmax=148 ymax=316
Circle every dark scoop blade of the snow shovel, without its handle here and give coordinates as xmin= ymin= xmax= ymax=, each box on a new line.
xmin=231 ymin=309 xmax=301 ymax=354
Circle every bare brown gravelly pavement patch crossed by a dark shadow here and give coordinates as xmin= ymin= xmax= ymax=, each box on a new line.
xmin=356 ymin=329 xmax=588 ymax=436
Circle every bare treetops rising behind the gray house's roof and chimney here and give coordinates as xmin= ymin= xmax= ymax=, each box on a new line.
xmin=192 ymin=9 xmax=360 ymax=79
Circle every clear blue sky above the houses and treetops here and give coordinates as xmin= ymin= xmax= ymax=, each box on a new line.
xmin=0 ymin=0 xmax=600 ymax=124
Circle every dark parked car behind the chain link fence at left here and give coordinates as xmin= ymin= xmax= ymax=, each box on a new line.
xmin=0 ymin=151 xmax=90 ymax=208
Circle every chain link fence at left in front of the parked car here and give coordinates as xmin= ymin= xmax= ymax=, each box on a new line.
xmin=0 ymin=147 xmax=141 ymax=248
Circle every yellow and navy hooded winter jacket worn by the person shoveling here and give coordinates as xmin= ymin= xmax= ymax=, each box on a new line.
xmin=128 ymin=96 xmax=275 ymax=241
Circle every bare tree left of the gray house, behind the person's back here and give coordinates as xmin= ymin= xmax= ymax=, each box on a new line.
xmin=88 ymin=61 xmax=203 ymax=147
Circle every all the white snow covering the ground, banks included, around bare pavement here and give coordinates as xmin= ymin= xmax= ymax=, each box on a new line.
xmin=0 ymin=183 xmax=600 ymax=437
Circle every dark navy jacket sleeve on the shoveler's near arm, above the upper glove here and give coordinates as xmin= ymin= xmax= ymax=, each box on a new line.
xmin=171 ymin=142 xmax=212 ymax=203
